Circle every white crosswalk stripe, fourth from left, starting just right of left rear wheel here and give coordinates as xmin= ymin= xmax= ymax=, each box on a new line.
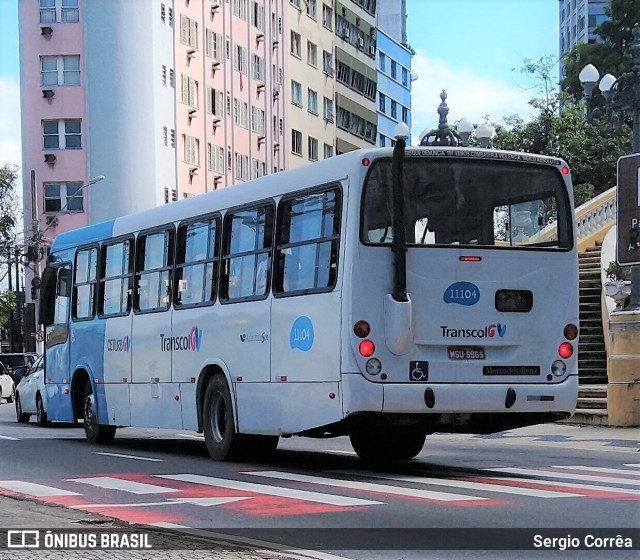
xmin=242 ymin=471 xmax=486 ymax=502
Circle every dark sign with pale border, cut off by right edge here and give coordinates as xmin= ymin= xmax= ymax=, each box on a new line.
xmin=616 ymin=154 xmax=640 ymax=265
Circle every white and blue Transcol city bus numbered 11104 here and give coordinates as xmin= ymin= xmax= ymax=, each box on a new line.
xmin=39 ymin=142 xmax=578 ymax=461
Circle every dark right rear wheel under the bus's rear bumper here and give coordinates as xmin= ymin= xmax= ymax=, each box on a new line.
xmin=349 ymin=428 xmax=427 ymax=464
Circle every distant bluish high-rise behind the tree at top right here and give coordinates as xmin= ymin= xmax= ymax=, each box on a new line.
xmin=558 ymin=0 xmax=609 ymax=79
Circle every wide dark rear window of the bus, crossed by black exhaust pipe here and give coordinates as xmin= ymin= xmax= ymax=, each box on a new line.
xmin=361 ymin=157 xmax=572 ymax=249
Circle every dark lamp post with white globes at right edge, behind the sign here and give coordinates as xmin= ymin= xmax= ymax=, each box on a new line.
xmin=578 ymin=23 xmax=640 ymax=311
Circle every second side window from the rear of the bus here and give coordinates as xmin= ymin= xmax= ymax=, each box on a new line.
xmin=220 ymin=205 xmax=274 ymax=301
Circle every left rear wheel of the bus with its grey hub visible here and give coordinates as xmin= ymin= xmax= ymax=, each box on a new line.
xmin=204 ymin=375 xmax=242 ymax=461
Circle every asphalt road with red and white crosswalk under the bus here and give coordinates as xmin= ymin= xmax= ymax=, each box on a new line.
xmin=0 ymin=396 xmax=640 ymax=560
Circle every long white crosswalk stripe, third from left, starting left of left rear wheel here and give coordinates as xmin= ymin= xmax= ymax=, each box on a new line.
xmin=156 ymin=474 xmax=383 ymax=506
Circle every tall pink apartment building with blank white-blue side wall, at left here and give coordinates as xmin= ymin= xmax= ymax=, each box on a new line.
xmin=19 ymin=0 xmax=287 ymax=237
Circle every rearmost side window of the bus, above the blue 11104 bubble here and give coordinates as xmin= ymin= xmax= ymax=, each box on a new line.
xmin=274 ymin=188 xmax=340 ymax=294
